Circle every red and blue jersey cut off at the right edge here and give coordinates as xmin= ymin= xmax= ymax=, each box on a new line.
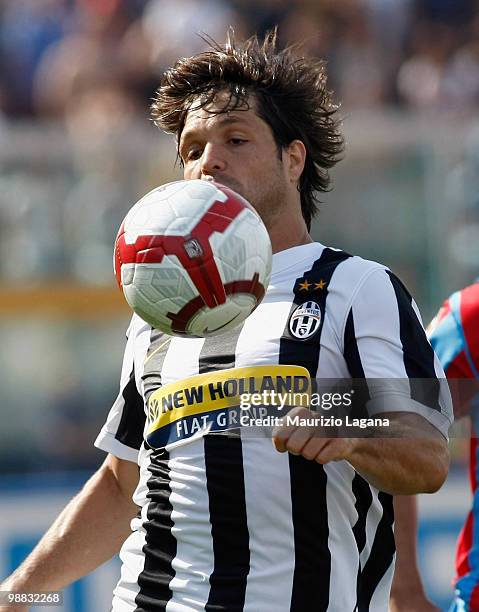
xmin=430 ymin=282 xmax=479 ymax=612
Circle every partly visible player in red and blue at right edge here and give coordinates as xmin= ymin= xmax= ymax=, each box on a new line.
xmin=390 ymin=281 xmax=479 ymax=612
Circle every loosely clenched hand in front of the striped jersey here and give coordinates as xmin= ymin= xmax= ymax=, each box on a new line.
xmin=273 ymin=407 xmax=356 ymax=464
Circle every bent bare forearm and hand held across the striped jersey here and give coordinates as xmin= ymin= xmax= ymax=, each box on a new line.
xmin=273 ymin=408 xmax=449 ymax=495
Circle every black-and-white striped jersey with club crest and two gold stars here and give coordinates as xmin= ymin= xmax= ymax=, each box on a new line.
xmin=96 ymin=243 xmax=451 ymax=612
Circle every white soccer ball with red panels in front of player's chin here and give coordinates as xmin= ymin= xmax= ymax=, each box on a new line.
xmin=114 ymin=180 xmax=271 ymax=337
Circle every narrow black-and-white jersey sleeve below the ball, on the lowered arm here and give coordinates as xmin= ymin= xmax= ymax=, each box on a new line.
xmin=95 ymin=319 xmax=146 ymax=463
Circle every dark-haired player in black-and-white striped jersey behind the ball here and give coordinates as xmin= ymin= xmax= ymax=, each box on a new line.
xmin=2 ymin=33 xmax=451 ymax=612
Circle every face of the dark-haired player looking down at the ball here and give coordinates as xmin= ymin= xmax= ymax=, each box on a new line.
xmin=179 ymin=94 xmax=288 ymax=227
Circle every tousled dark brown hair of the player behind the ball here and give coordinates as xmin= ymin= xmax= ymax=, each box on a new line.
xmin=152 ymin=28 xmax=344 ymax=229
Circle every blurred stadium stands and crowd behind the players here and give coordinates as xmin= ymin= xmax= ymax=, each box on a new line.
xmin=0 ymin=0 xmax=479 ymax=612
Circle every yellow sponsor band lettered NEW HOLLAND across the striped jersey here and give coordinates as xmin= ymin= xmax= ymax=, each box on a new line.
xmin=148 ymin=365 xmax=311 ymax=434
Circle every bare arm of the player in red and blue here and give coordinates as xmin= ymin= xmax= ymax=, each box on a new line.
xmin=389 ymin=495 xmax=439 ymax=612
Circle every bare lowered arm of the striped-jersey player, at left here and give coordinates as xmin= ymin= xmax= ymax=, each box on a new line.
xmin=0 ymin=455 xmax=139 ymax=610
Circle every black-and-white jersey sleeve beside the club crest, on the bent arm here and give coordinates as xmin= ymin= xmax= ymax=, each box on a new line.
xmin=344 ymin=268 xmax=452 ymax=438
